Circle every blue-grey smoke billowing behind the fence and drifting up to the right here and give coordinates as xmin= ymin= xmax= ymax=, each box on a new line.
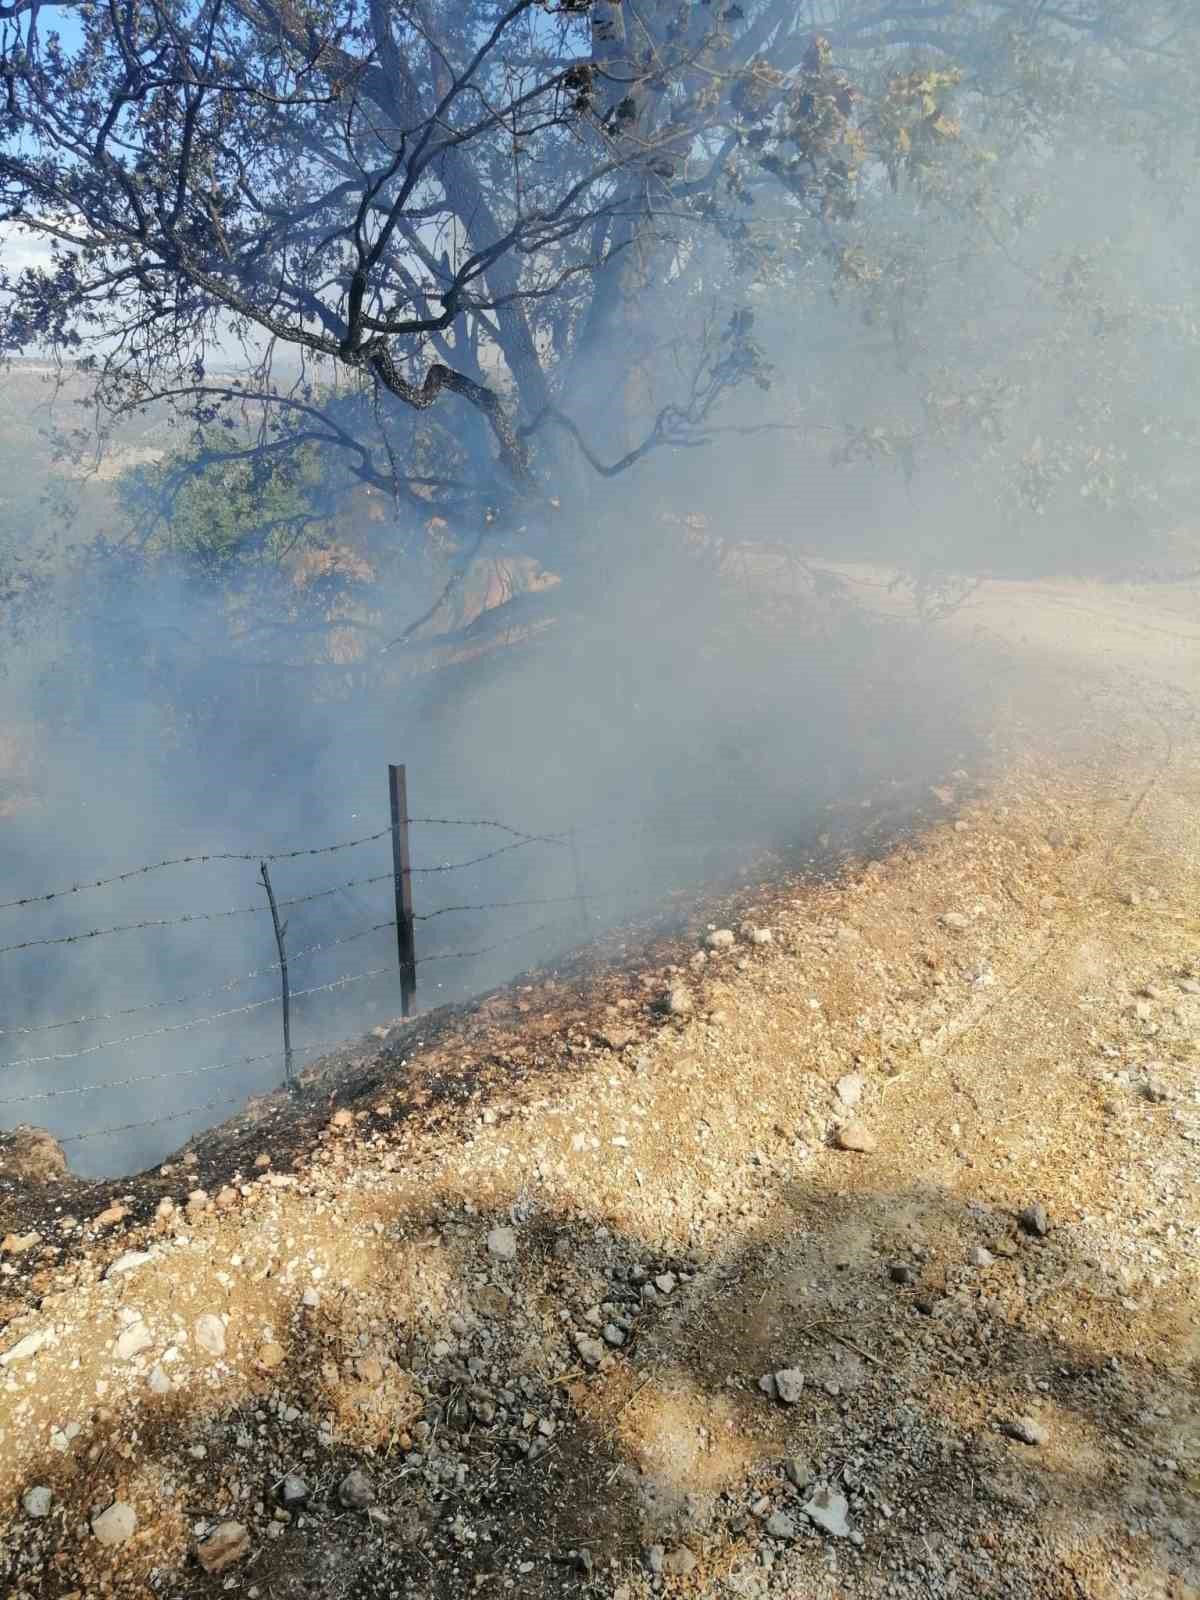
xmin=0 ymin=109 xmax=1200 ymax=1173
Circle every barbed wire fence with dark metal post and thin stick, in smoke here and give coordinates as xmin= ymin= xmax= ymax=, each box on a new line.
xmin=0 ymin=768 xmax=752 ymax=1171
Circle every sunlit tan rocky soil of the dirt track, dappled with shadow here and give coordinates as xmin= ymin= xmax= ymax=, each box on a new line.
xmin=0 ymin=576 xmax=1200 ymax=1600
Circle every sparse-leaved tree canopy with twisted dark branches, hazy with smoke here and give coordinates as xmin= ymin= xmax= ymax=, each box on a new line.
xmin=0 ymin=0 xmax=1200 ymax=576
